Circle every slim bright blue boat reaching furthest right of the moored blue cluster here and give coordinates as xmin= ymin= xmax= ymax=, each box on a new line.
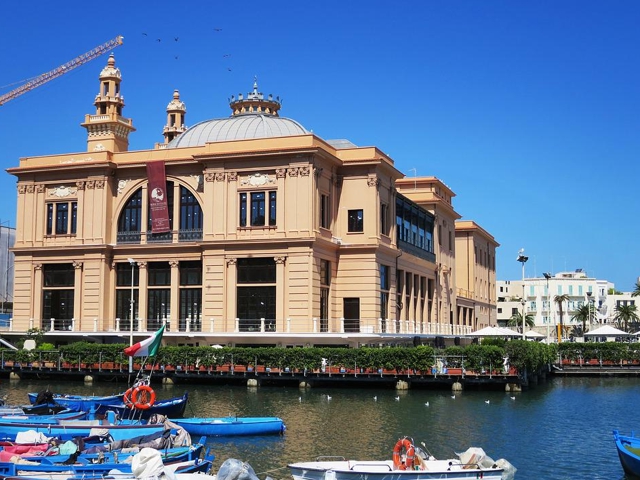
xmin=170 ymin=417 xmax=286 ymax=437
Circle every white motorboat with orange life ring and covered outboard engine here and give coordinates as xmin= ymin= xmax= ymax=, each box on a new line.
xmin=288 ymin=437 xmax=516 ymax=480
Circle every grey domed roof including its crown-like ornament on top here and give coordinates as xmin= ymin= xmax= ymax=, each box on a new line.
xmin=167 ymin=83 xmax=309 ymax=148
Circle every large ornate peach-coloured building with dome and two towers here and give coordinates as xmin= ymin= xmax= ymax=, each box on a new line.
xmin=2 ymin=55 xmax=497 ymax=346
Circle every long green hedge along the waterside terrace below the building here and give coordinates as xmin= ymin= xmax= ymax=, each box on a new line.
xmin=2 ymin=340 xmax=560 ymax=373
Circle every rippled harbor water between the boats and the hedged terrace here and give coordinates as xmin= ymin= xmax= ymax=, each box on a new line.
xmin=0 ymin=378 xmax=640 ymax=480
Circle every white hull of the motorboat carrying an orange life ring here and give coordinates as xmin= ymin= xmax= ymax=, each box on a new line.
xmin=289 ymin=460 xmax=503 ymax=480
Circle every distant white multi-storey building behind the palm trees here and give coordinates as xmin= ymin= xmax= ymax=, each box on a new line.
xmin=496 ymin=269 xmax=616 ymax=341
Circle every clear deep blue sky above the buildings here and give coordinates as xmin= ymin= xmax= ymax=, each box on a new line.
xmin=0 ymin=0 xmax=640 ymax=291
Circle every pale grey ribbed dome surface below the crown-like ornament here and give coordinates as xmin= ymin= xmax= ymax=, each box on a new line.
xmin=167 ymin=113 xmax=309 ymax=148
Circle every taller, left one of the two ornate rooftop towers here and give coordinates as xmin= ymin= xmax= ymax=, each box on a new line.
xmin=82 ymin=54 xmax=135 ymax=152
